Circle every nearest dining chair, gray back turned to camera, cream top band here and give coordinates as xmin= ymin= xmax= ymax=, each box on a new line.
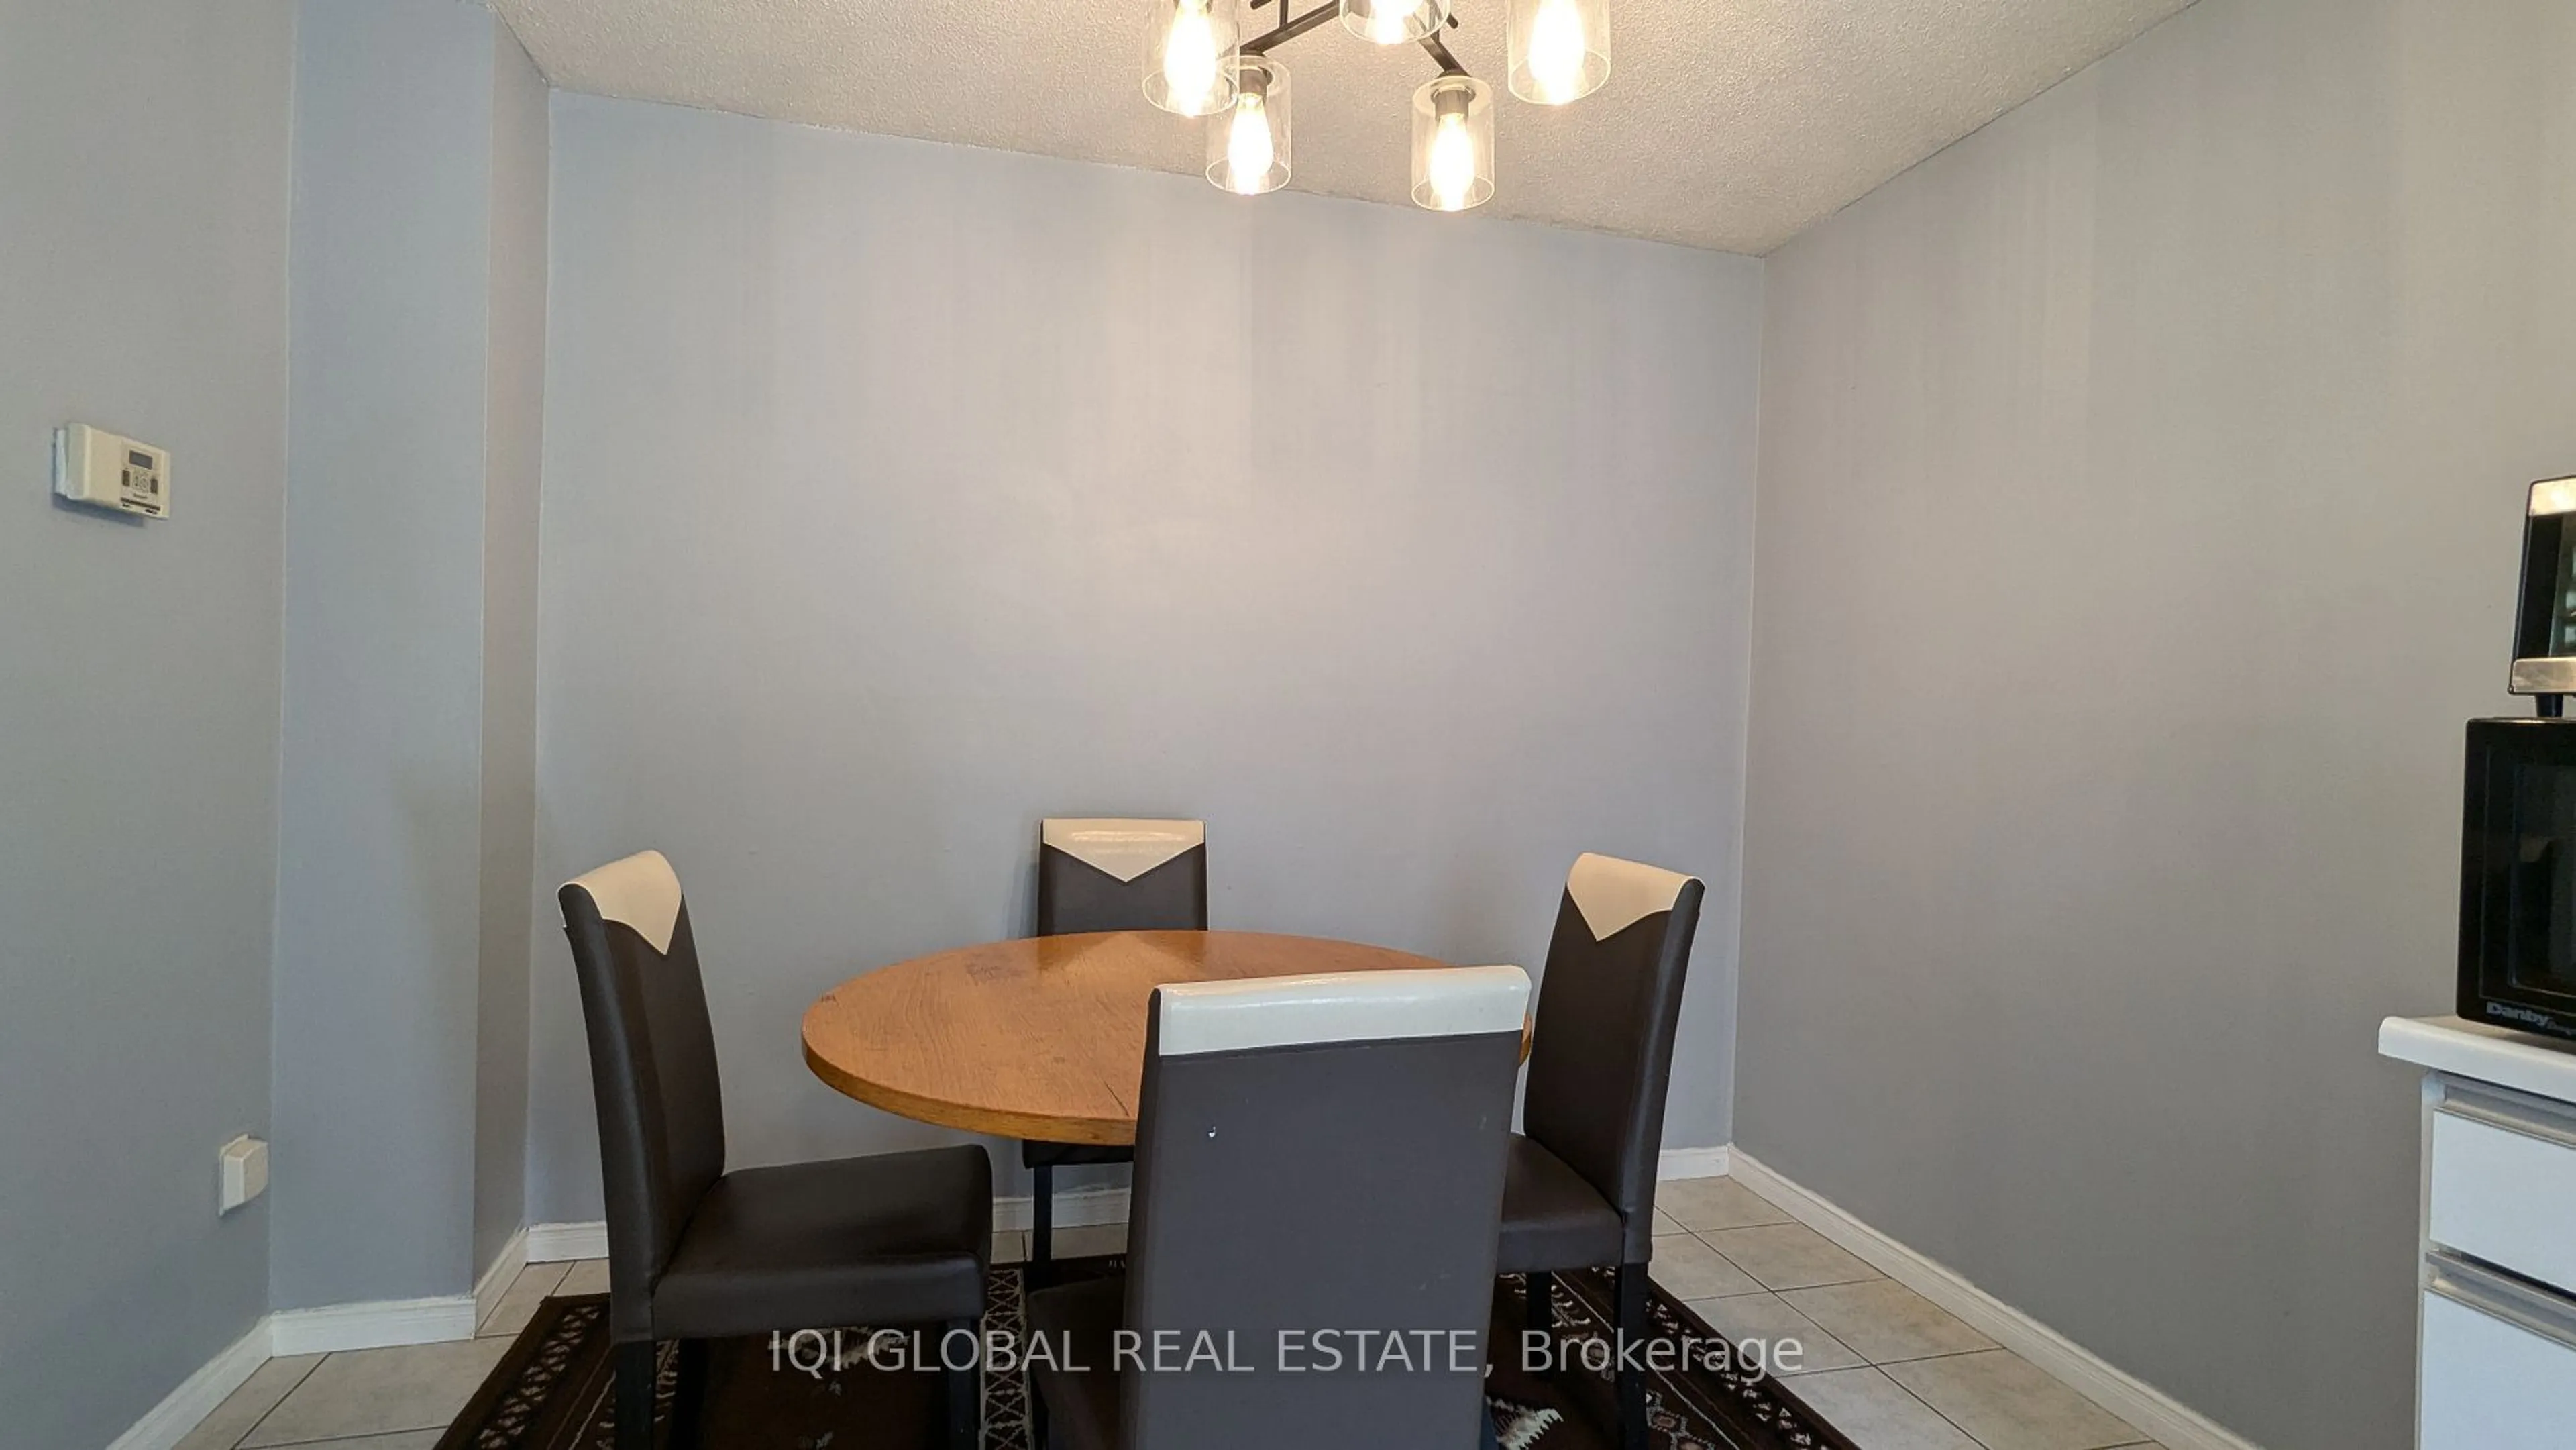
xmin=1028 ymin=966 xmax=1530 ymax=1450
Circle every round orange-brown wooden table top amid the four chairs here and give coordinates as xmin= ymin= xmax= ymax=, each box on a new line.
xmin=804 ymin=932 xmax=1448 ymax=1143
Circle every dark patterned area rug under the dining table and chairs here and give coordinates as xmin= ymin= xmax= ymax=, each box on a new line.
xmin=438 ymin=1259 xmax=1858 ymax=1450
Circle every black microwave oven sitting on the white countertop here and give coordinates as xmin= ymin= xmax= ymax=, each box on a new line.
xmin=2460 ymin=719 xmax=2576 ymax=1038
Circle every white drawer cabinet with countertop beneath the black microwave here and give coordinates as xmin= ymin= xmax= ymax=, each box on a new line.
xmin=2380 ymin=1017 xmax=2576 ymax=1450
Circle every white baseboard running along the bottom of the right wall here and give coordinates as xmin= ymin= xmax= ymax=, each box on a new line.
xmin=1731 ymin=1149 xmax=2259 ymax=1450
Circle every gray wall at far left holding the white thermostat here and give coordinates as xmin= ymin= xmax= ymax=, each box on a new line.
xmin=0 ymin=0 xmax=294 ymax=1450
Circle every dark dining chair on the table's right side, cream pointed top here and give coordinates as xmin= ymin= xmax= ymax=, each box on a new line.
xmin=1499 ymin=852 xmax=1703 ymax=1450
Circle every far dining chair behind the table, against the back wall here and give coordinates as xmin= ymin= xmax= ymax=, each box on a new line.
xmin=1020 ymin=817 xmax=1208 ymax=1265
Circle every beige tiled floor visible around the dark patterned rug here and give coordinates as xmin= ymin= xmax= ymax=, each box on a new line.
xmin=178 ymin=1177 xmax=2153 ymax=1450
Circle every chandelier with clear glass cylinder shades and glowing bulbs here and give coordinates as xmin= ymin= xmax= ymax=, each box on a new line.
xmin=1144 ymin=0 xmax=1610 ymax=211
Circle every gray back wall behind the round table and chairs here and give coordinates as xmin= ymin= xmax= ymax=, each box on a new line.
xmin=531 ymin=95 xmax=1760 ymax=1221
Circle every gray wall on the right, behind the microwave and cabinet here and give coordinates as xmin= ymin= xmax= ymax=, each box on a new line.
xmin=1736 ymin=0 xmax=2576 ymax=1450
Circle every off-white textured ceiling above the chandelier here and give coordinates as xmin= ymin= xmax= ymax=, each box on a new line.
xmin=492 ymin=0 xmax=2190 ymax=255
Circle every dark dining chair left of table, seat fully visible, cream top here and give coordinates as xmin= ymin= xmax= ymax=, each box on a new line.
xmin=559 ymin=850 xmax=991 ymax=1450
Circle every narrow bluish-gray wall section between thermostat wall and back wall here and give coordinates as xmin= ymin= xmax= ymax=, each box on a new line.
xmin=270 ymin=0 xmax=543 ymax=1308
